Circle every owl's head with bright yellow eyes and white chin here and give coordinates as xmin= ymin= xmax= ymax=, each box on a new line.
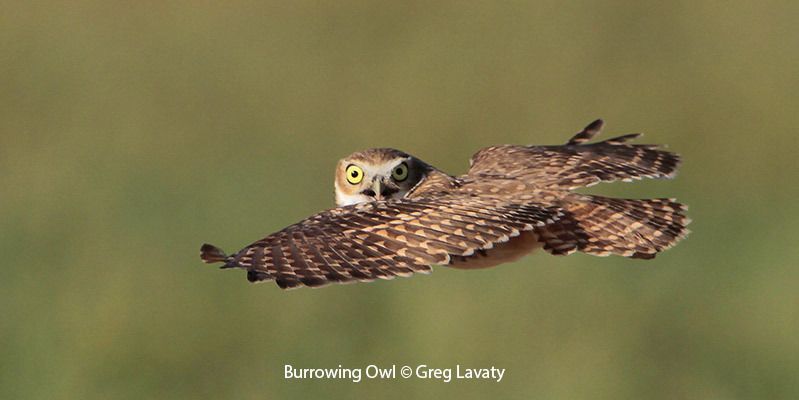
xmin=335 ymin=149 xmax=432 ymax=207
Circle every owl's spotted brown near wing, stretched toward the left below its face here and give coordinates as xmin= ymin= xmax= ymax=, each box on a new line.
xmin=201 ymin=194 xmax=560 ymax=289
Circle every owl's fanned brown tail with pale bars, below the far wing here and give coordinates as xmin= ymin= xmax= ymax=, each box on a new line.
xmin=538 ymin=194 xmax=691 ymax=259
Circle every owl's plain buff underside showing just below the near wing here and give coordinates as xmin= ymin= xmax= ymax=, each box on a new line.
xmin=449 ymin=232 xmax=543 ymax=269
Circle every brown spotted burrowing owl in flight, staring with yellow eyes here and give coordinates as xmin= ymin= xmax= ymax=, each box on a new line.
xmin=201 ymin=120 xmax=689 ymax=288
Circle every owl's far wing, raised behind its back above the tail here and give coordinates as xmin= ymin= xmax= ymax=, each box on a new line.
xmin=468 ymin=120 xmax=680 ymax=190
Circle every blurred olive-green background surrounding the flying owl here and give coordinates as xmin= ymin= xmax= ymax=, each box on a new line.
xmin=0 ymin=1 xmax=799 ymax=399
